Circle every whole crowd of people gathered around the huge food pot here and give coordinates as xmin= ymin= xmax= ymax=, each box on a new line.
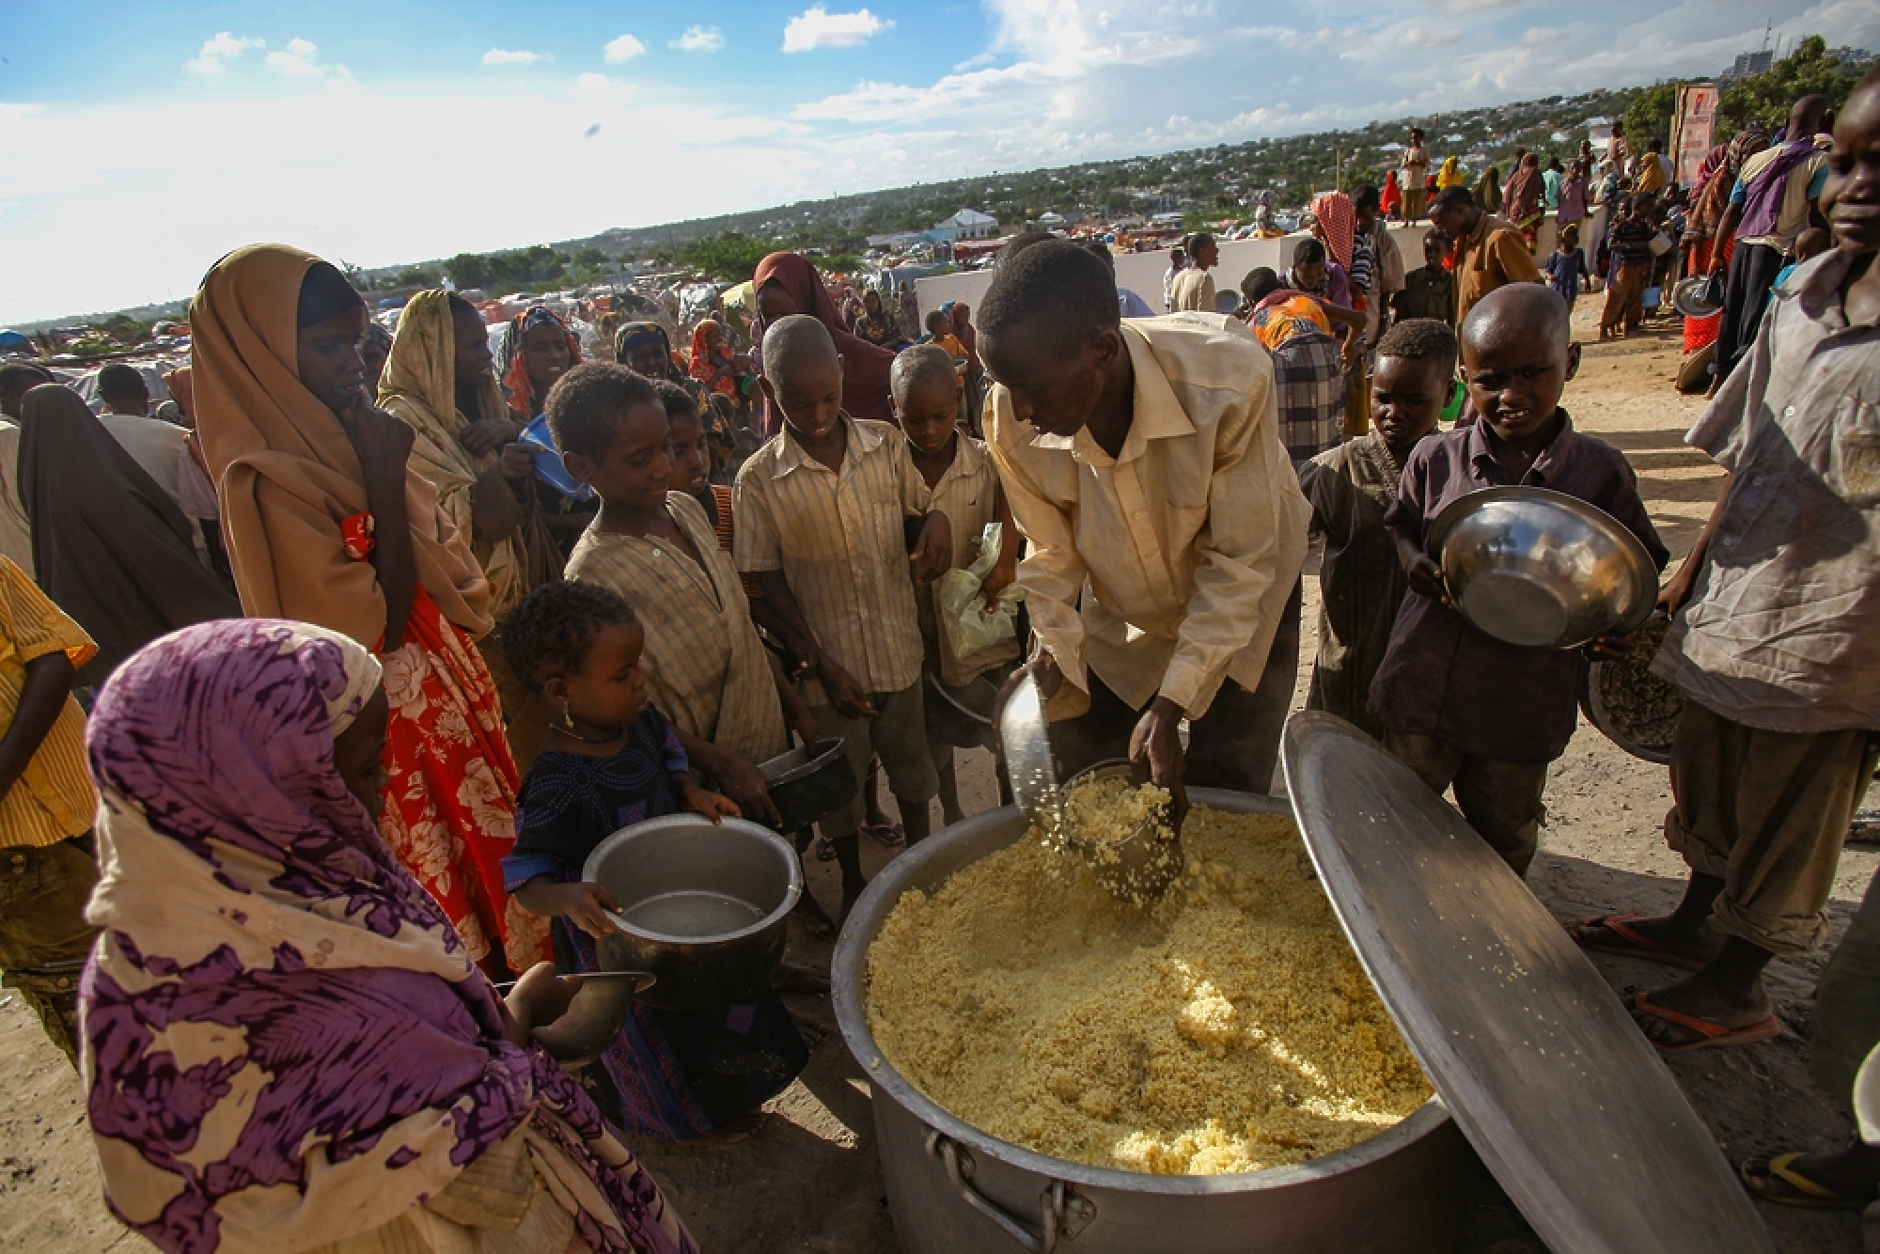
xmin=0 ymin=66 xmax=1880 ymax=1252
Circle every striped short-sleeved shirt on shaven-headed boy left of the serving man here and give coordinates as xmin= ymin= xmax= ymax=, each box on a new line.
xmin=735 ymin=415 xmax=927 ymax=705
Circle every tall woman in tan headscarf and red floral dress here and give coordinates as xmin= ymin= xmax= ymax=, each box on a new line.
xmin=190 ymin=244 xmax=547 ymax=972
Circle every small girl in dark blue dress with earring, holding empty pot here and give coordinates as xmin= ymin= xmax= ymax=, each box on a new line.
xmin=502 ymin=581 xmax=808 ymax=1141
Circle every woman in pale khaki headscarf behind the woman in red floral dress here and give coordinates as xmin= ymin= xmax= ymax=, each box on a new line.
xmin=378 ymin=291 xmax=560 ymax=775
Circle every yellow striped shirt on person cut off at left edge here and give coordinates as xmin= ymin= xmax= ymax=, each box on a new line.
xmin=0 ymin=556 xmax=98 ymax=848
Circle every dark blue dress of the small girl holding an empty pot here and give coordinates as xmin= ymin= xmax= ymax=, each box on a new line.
xmin=502 ymin=707 xmax=808 ymax=1141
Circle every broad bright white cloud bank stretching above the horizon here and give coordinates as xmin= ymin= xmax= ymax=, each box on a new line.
xmin=0 ymin=0 xmax=1880 ymax=325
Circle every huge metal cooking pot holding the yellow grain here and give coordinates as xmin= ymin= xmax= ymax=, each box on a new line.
xmin=833 ymin=788 xmax=1468 ymax=1254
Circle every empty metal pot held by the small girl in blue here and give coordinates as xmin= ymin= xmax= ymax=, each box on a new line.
xmin=581 ymin=814 xmax=803 ymax=1010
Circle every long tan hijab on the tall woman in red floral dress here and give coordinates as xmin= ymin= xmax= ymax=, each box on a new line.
xmin=190 ymin=244 xmax=491 ymax=649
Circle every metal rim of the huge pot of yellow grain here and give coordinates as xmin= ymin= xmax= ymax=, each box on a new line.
xmin=831 ymin=788 xmax=1449 ymax=1198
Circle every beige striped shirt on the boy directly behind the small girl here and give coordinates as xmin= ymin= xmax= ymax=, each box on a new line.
xmin=568 ymin=493 xmax=790 ymax=763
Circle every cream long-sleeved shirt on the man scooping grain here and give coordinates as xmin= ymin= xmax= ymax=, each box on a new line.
xmin=989 ymin=314 xmax=1310 ymax=718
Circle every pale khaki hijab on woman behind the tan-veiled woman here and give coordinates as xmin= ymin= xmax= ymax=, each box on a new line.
xmin=378 ymin=290 xmax=528 ymax=615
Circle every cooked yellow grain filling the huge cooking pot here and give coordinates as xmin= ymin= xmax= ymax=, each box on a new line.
xmin=867 ymin=807 xmax=1431 ymax=1175
